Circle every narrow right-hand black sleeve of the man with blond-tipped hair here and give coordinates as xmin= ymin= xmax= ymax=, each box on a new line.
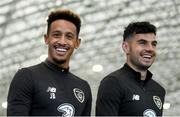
xmin=82 ymin=84 xmax=92 ymax=116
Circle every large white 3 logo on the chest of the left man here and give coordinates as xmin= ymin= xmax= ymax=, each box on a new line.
xmin=57 ymin=103 xmax=75 ymax=117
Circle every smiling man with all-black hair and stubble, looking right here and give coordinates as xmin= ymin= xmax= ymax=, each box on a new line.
xmin=96 ymin=22 xmax=165 ymax=117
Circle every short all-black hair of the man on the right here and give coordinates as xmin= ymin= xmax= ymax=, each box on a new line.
xmin=123 ymin=21 xmax=157 ymax=41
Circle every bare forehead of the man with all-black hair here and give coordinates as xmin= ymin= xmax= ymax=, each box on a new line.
xmin=132 ymin=33 xmax=156 ymax=41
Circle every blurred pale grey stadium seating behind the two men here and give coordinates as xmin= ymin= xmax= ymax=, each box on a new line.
xmin=0 ymin=0 xmax=180 ymax=116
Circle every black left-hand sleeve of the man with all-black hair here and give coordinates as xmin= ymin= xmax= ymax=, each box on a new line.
xmin=95 ymin=76 xmax=123 ymax=116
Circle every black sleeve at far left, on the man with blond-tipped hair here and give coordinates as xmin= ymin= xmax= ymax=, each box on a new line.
xmin=7 ymin=68 xmax=33 ymax=116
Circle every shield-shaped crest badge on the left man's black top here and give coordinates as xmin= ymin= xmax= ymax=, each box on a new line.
xmin=73 ymin=88 xmax=84 ymax=103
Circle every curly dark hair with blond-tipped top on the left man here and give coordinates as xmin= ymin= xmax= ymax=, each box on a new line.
xmin=47 ymin=8 xmax=81 ymax=36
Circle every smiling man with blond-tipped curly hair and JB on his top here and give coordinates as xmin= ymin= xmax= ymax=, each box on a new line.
xmin=7 ymin=9 xmax=92 ymax=117
